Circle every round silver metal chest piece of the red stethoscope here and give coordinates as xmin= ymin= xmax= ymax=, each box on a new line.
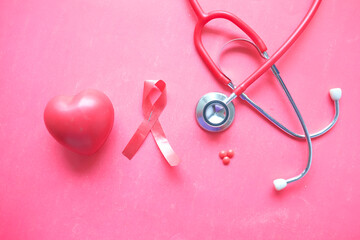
xmin=196 ymin=92 xmax=235 ymax=132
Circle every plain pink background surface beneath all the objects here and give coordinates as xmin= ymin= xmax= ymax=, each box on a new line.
xmin=0 ymin=0 xmax=360 ymax=240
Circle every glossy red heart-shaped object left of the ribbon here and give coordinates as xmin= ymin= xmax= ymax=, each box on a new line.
xmin=44 ymin=89 xmax=114 ymax=154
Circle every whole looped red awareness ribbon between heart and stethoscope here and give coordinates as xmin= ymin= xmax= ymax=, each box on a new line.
xmin=123 ymin=80 xmax=180 ymax=166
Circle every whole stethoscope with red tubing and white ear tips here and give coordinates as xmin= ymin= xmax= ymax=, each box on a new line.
xmin=189 ymin=0 xmax=341 ymax=190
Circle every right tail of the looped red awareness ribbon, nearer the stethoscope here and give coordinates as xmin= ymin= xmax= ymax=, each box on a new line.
xmin=151 ymin=121 xmax=181 ymax=167
